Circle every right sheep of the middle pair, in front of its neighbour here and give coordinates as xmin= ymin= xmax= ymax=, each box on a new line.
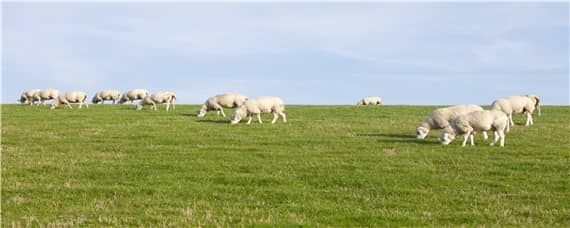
xmin=231 ymin=97 xmax=287 ymax=124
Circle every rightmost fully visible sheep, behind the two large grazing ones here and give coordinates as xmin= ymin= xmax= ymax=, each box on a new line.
xmin=491 ymin=96 xmax=536 ymax=127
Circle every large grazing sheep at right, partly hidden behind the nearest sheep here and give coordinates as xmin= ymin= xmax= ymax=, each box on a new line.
xmin=416 ymin=105 xmax=488 ymax=140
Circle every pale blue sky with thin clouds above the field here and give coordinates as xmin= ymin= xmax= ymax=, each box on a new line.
xmin=1 ymin=2 xmax=570 ymax=105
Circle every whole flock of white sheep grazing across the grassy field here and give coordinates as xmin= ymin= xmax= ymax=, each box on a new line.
xmin=15 ymin=89 xmax=540 ymax=146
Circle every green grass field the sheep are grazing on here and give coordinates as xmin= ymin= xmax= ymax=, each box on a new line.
xmin=1 ymin=105 xmax=570 ymax=227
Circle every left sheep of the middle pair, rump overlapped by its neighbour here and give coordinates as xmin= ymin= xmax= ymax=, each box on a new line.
xmin=196 ymin=93 xmax=247 ymax=117
